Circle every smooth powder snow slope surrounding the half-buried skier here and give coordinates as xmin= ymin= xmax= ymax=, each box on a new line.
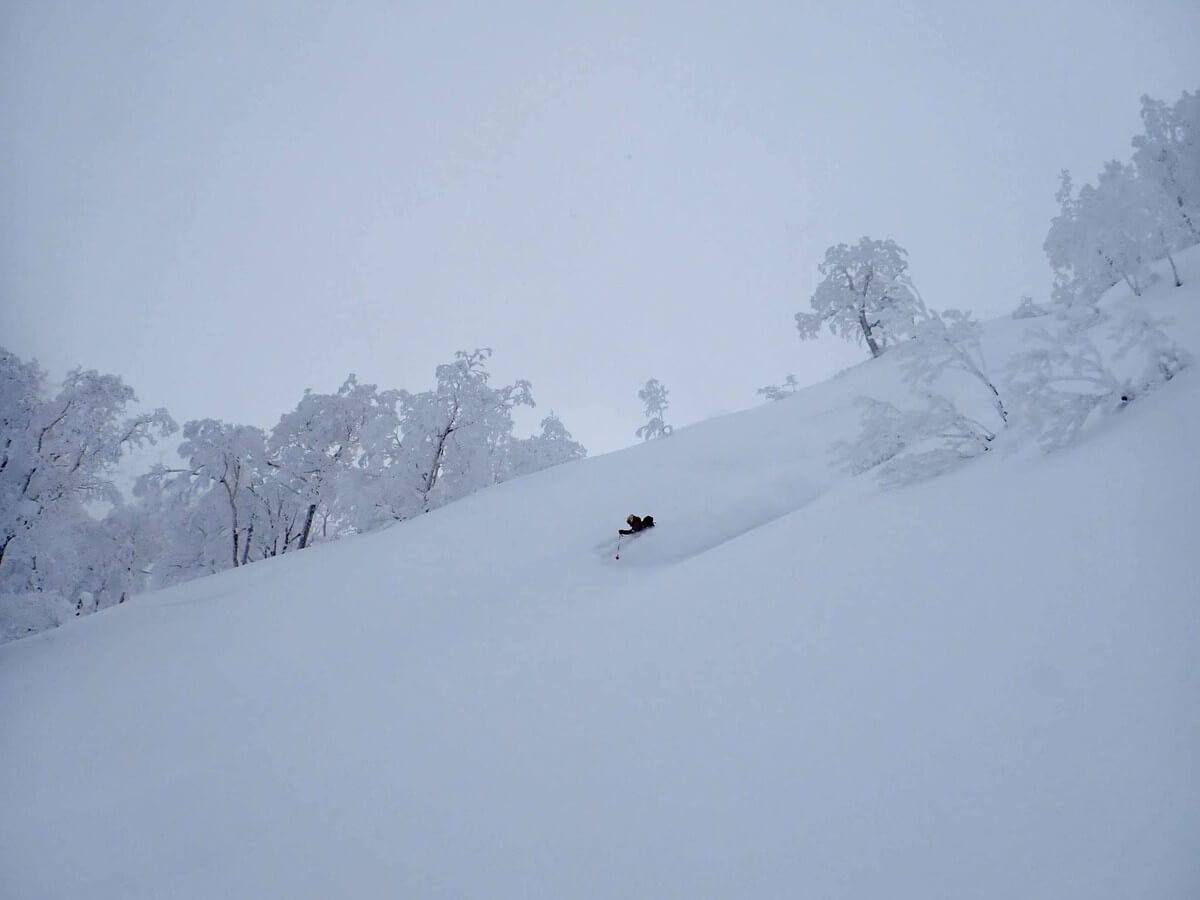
xmin=7 ymin=252 xmax=1200 ymax=900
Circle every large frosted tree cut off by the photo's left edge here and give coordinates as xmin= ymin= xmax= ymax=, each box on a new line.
xmin=0 ymin=349 xmax=175 ymax=637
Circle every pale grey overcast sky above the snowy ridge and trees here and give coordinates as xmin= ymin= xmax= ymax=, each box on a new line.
xmin=0 ymin=0 xmax=1200 ymax=454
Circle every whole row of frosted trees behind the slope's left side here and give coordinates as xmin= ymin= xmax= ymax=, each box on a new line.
xmin=0 ymin=348 xmax=587 ymax=640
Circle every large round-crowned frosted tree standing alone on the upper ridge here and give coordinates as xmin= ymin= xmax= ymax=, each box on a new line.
xmin=796 ymin=238 xmax=923 ymax=356
